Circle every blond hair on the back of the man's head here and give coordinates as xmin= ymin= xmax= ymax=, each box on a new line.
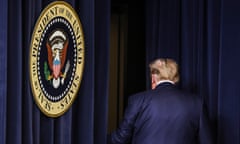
xmin=149 ymin=58 xmax=179 ymax=83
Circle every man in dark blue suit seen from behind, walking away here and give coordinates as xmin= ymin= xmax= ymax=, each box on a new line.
xmin=108 ymin=59 xmax=212 ymax=144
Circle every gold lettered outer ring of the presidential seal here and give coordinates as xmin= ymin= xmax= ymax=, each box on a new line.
xmin=29 ymin=1 xmax=85 ymax=117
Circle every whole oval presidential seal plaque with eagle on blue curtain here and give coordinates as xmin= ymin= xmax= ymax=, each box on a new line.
xmin=29 ymin=1 xmax=85 ymax=117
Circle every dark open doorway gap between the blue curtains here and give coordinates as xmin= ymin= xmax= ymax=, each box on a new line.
xmin=108 ymin=0 xmax=147 ymax=132
